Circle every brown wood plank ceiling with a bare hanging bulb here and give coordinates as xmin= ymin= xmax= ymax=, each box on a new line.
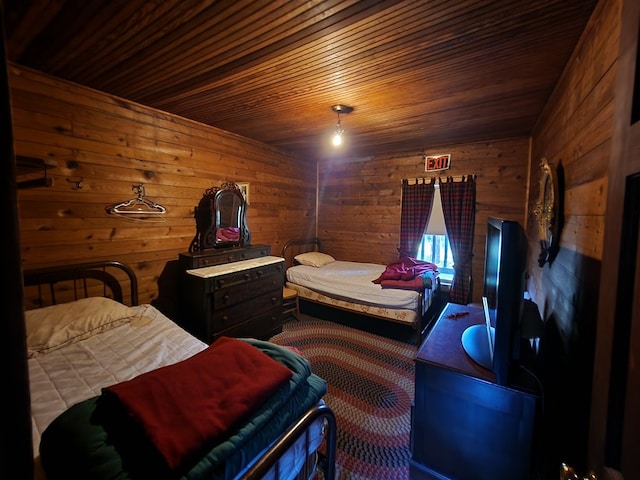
xmin=2 ymin=0 xmax=597 ymax=159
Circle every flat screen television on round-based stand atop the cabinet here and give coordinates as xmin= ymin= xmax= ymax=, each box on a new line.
xmin=463 ymin=217 xmax=527 ymax=385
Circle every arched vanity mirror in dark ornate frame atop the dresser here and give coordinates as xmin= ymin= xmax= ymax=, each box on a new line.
xmin=189 ymin=182 xmax=251 ymax=252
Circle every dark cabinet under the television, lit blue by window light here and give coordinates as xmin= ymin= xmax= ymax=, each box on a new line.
xmin=410 ymin=303 xmax=539 ymax=480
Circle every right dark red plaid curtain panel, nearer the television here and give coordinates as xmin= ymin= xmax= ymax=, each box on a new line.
xmin=440 ymin=175 xmax=476 ymax=305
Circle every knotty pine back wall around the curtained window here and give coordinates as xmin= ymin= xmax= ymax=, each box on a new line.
xmin=318 ymin=137 xmax=529 ymax=302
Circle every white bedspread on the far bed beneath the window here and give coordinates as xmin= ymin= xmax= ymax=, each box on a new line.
xmin=287 ymin=260 xmax=420 ymax=310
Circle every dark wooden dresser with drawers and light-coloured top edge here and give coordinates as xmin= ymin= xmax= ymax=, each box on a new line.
xmin=180 ymin=246 xmax=285 ymax=343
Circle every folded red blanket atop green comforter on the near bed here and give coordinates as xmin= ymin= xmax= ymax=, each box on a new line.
xmin=104 ymin=337 xmax=292 ymax=469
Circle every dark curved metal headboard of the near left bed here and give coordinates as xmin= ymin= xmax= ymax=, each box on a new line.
xmin=23 ymin=261 xmax=138 ymax=309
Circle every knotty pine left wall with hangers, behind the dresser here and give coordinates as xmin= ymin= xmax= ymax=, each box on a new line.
xmin=9 ymin=65 xmax=315 ymax=307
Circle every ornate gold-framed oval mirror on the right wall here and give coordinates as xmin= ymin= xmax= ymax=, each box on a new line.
xmin=533 ymin=158 xmax=560 ymax=267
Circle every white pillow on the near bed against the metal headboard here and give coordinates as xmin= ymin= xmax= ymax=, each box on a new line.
xmin=24 ymin=297 xmax=136 ymax=358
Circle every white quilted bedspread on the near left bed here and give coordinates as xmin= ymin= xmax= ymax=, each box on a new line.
xmin=29 ymin=305 xmax=207 ymax=468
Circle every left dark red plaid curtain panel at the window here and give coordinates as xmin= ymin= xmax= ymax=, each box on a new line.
xmin=398 ymin=178 xmax=435 ymax=258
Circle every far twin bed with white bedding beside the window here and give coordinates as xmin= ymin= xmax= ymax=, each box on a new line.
xmin=282 ymin=238 xmax=437 ymax=332
